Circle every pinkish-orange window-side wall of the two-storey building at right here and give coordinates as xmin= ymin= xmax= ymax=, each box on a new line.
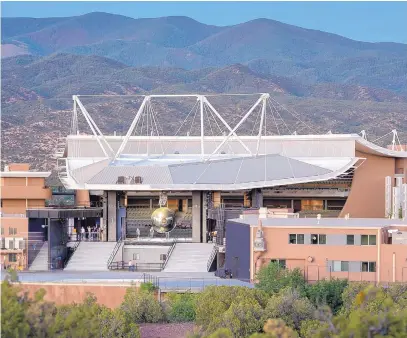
xmin=247 ymin=227 xmax=407 ymax=282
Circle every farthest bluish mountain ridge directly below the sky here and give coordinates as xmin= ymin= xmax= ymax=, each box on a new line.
xmin=2 ymin=13 xmax=407 ymax=93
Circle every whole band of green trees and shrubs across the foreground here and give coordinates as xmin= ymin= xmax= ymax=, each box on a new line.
xmin=1 ymin=263 xmax=407 ymax=338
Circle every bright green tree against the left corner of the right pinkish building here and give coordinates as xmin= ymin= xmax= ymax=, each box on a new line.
xmin=256 ymin=262 xmax=306 ymax=294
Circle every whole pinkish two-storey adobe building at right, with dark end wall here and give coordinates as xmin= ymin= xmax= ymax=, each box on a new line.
xmin=225 ymin=215 xmax=407 ymax=283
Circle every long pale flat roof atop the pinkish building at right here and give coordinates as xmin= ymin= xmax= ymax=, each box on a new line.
xmin=228 ymin=215 xmax=407 ymax=229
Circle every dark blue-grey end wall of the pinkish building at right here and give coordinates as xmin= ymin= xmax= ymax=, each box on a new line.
xmin=225 ymin=221 xmax=250 ymax=279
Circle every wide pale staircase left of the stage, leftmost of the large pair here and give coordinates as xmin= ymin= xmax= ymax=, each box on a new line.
xmin=64 ymin=242 xmax=116 ymax=271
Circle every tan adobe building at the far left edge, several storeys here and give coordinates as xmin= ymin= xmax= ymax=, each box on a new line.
xmin=0 ymin=163 xmax=52 ymax=269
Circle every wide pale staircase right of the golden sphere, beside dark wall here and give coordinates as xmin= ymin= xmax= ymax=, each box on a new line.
xmin=163 ymin=243 xmax=217 ymax=272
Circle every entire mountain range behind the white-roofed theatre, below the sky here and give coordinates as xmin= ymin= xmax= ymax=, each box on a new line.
xmin=1 ymin=13 xmax=407 ymax=174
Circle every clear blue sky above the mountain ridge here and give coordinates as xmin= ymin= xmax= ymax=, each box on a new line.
xmin=1 ymin=1 xmax=407 ymax=43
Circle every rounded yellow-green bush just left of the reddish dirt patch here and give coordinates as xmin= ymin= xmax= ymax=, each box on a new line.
xmin=121 ymin=288 xmax=164 ymax=323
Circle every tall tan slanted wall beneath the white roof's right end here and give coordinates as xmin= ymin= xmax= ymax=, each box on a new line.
xmin=340 ymin=152 xmax=395 ymax=218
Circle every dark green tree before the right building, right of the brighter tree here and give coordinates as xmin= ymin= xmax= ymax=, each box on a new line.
xmin=306 ymin=279 xmax=348 ymax=313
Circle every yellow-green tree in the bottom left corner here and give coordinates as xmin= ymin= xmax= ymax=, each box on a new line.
xmin=1 ymin=280 xmax=30 ymax=338
